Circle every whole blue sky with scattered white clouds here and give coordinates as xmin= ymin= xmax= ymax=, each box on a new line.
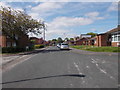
xmin=0 ymin=2 xmax=118 ymax=40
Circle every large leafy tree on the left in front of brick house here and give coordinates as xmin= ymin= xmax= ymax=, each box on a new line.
xmin=0 ymin=7 xmax=43 ymax=44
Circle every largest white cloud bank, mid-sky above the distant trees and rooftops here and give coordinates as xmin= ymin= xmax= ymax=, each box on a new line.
xmin=47 ymin=12 xmax=104 ymax=38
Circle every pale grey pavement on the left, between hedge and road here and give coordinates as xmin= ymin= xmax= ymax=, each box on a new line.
xmin=0 ymin=48 xmax=46 ymax=72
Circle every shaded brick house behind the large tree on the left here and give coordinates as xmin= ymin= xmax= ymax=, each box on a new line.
xmin=0 ymin=32 xmax=29 ymax=47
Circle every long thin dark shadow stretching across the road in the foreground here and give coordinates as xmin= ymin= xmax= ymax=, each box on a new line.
xmin=0 ymin=74 xmax=85 ymax=84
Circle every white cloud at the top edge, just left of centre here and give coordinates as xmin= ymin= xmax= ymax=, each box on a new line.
xmin=29 ymin=2 xmax=65 ymax=18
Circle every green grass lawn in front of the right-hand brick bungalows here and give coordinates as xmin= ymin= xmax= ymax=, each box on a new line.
xmin=71 ymin=45 xmax=120 ymax=52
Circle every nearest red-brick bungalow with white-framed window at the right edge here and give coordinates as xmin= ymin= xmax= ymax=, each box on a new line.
xmin=94 ymin=27 xmax=120 ymax=47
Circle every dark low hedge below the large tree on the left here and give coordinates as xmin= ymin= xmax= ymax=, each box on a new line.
xmin=2 ymin=47 xmax=26 ymax=53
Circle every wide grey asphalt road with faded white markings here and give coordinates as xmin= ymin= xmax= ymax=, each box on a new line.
xmin=2 ymin=47 xmax=118 ymax=88
